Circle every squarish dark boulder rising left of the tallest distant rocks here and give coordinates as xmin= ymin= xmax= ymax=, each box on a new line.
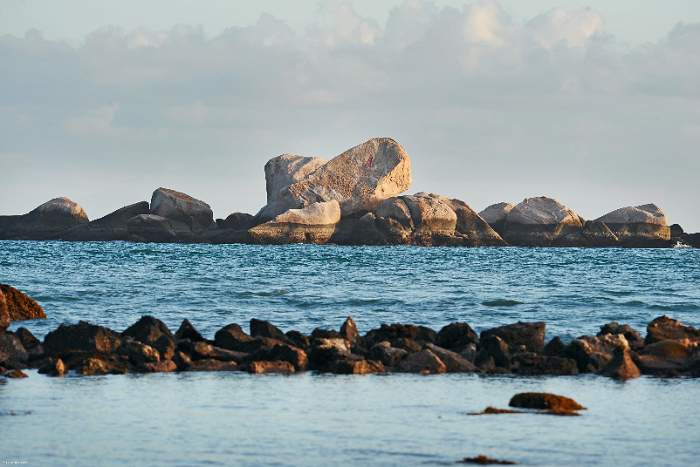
xmin=150 ymin=188 xmax=217 ymax=233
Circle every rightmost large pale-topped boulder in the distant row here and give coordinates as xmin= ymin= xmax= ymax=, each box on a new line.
xmin=596 ymin=204 xmax=671 ymax=247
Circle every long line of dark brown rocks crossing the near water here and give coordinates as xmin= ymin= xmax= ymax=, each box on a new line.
xmin=0 ymin=310 xmax=700 ymax=380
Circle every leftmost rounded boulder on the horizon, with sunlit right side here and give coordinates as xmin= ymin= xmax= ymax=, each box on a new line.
xmin=0 ymin=198 xmax=88 ymax=240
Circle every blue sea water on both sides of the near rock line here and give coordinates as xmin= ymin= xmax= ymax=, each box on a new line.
xmin=0 ymin=241 xmax=700 ymax=466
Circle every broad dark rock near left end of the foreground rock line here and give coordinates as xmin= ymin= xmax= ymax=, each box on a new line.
xmin=44 ymin=321 xmax=121 ymax=361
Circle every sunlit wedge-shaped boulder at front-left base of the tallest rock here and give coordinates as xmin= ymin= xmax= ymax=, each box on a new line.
xmin=248 ymin=199 xmax=340 ymax=244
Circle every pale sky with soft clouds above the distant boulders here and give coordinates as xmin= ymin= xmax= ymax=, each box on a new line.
xmin=0 ymin=0 xmax=700 ymax=232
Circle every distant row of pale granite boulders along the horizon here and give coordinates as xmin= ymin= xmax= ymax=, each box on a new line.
xmin=0 ymin=138 xmax=700 ymax=247
